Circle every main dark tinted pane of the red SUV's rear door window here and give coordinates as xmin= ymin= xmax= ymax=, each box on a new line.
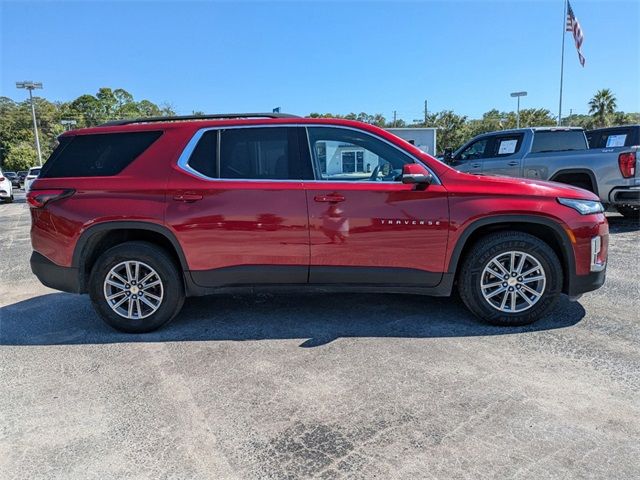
xmin=220 ymin=127 xmax=302 ymax=180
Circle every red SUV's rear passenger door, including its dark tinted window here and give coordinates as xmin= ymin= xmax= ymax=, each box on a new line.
xmin=166 ymin=126 xmax=311 ymax=287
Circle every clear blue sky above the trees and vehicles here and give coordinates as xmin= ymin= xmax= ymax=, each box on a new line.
xmin=0 ymin=0 xmax=640 ymax=121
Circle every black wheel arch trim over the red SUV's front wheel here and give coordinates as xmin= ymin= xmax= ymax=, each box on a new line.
xmin=447 ymin=214 xmax=576 ymax=283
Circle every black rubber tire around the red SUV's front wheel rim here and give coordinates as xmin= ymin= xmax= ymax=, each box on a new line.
xmin=458 ymin=232 xmax=562 ymax=326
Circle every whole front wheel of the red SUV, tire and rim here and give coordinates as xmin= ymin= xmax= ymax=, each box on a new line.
xmin=458 ymin=232 xmax=562 ymax=326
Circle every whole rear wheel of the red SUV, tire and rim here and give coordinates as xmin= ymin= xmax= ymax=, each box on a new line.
xmin=89 ymin=242 xmax=184 ymax=333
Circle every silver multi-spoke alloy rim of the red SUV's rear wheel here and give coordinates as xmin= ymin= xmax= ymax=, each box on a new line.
xmin=103 ymin=260 xmax=164 ymax=320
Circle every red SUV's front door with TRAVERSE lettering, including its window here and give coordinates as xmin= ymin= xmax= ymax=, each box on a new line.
xmin=305 ymin=126 xmax=449 ymax=287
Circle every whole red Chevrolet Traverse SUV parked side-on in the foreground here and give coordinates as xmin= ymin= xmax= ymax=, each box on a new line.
xmin=28 ymin=114 xmax=608 ymax=332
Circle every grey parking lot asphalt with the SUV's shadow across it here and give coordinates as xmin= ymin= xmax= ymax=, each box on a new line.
xmin=0 ymin=189 xmax=640 ymax=479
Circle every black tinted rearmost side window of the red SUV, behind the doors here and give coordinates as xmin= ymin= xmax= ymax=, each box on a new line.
xmin=40 ymin=132 xmax=162 ymax=178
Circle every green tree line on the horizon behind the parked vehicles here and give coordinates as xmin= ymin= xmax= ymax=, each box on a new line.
xmin=0 ymin=88 xmax=640 ymax=171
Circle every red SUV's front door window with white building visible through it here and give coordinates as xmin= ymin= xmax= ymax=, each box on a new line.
xmin=308 ymin=127 xmax=413 ymax=182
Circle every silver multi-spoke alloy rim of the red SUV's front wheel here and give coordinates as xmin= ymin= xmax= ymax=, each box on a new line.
xmin=480 ymin=251 xmax=547 ymax=313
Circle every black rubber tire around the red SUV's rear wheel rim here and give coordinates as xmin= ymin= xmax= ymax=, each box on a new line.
xmin=89 ymin=241 xmax=185 ymax=333
